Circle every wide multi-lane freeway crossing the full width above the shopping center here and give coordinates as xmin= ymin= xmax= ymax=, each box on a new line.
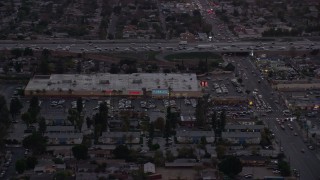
xmin=0 ymin=40 xmax=320 ymax=53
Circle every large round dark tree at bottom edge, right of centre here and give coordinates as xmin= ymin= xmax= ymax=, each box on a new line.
xmin=218 ymin=156 xmax=242 ymax=178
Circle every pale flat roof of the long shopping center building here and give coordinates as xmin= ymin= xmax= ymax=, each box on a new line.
xmin=25 ymin=73 xmax=200 ymax=92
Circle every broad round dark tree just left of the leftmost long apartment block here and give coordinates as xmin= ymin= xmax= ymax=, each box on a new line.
xmin=22 ymin=132 xmax=47 ymax=155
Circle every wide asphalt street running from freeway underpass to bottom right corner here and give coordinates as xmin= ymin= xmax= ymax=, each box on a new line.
xmin=238 ymin=58 xmax=320 ymax=180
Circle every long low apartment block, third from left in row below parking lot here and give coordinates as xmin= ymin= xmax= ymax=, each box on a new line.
xmin=176 ymin=131 xmax=215 ymax=144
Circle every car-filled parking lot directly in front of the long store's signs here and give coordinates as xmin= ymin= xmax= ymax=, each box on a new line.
xmin=15 ymin=97 xmax=196 ymax=131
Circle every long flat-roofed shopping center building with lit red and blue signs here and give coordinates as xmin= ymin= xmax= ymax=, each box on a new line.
xmin=24 ymin=73 xmax=202 ymax=98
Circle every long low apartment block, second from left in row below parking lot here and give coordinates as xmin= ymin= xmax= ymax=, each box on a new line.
xmin=98 ymin=132 xmax=140 ymax=144
